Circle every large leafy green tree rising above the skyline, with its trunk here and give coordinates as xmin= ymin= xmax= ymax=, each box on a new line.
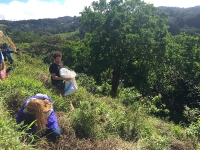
xmin=80 ymin=0 xmax=167 ymax=97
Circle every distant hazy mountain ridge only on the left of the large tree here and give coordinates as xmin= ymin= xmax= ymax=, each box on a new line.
xmin=0 ymin=16 xmax=79 ymax=35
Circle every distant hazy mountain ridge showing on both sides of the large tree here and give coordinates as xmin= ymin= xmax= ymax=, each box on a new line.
xmin=0 ymin=6 xmax=200 ymax=37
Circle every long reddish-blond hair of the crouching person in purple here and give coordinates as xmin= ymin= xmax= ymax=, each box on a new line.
xmin=25 ymin=99 xmax=52 ymax=131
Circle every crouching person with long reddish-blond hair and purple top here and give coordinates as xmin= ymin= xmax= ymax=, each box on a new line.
xmin=16 ymin=94 xmax=61 ymax=139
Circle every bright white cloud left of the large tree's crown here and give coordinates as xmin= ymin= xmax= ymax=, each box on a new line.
xmin=0 ymin=0 xmax=92 ymax=20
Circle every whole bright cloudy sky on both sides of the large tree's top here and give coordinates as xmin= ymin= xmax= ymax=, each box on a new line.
xmin=0 ymin=0 xmax=200 ymax=21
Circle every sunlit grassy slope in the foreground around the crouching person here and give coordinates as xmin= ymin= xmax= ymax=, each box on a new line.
xmin=0 ymin=54 xmax=197 ymax=150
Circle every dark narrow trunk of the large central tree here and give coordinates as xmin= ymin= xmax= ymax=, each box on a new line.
xmin=111 ymin=67 xmax=120 ymax=98
